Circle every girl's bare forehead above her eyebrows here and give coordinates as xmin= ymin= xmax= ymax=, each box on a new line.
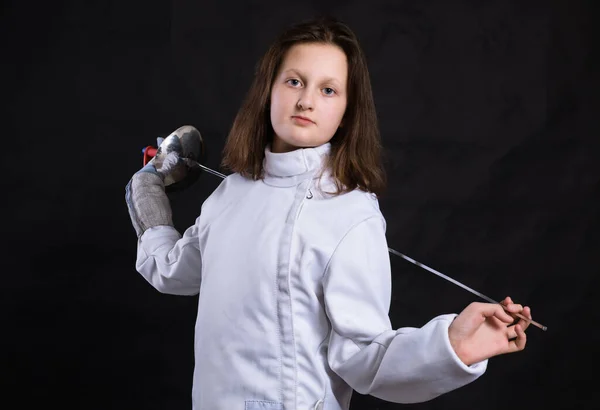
xmin=281 ymin=43 xmax=348 ymax=84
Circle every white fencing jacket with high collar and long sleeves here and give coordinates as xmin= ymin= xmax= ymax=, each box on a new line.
xmin=136 ymin=144 xmax=487 ymax=410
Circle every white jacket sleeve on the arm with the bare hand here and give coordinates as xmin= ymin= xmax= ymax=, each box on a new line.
xmin=323 ymin=216 xmax=487 ymax=403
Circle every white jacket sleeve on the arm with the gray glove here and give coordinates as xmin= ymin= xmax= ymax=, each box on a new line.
xmin=136 ymin=216 xmax=202 ymax=295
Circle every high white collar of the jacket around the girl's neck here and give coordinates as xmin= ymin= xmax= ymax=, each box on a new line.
xmin=263 ymin=143 xmax=331 ymax=186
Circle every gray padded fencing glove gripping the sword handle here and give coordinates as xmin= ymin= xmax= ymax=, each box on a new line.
xmin=125 ymin=152 xmax=181 ymax=238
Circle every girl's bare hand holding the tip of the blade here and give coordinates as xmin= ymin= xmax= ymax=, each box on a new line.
xmin=448 ymin=296 xmax=531 ymax=366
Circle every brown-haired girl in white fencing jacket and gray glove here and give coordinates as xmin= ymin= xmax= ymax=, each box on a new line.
xmin=127 ymin=16 xmax=531 ymax=410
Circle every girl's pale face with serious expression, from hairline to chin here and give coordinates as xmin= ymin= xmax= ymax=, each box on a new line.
xmin=271 ymin=43 xmax=348 ymax=152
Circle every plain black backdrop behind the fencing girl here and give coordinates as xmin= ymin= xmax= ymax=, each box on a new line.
xmin=0 ymin=0 xmax=600 ymax=410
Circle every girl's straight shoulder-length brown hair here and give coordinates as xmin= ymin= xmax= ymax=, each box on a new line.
xmin=222 ymin=17 xmax=386 ymax=195
